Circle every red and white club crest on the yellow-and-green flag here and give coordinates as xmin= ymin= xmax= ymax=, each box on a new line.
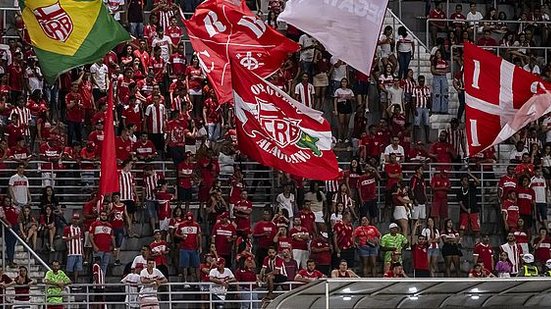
xmin=33 ymin=2 xmax=73 ymax=42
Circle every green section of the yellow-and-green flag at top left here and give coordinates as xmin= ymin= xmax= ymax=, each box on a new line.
xmin=34 ymin=4 xmax=130 ymax=84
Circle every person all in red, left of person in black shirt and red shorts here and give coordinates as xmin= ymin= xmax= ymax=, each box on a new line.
xmin=430 ymin=168 xmax=451 ymax=228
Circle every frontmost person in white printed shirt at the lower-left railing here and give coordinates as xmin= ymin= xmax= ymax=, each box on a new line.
xmin=139 ymin=258 xmax=167 ymax=309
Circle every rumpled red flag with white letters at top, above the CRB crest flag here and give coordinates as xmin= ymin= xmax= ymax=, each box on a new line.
xmin=183 ymin=0 xmax=300 ymax=103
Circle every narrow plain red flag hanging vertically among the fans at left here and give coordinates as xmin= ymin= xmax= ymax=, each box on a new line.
xmin=98 ymin=84 xmax=119 ymax=196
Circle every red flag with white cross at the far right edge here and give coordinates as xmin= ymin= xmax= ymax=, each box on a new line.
xmin=464 ymin=43 xmax=551 ymax=156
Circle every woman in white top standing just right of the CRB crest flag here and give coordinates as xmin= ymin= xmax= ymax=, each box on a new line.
xmin=333 ymin=78 xmax=356 ymax=144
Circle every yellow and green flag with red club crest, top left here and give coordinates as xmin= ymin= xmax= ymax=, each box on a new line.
xmin=19 ymin=0 xmax=130 ymax=83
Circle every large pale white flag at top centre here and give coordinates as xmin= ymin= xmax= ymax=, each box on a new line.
xmin=278 ymin=0 xmax=388 ymax=75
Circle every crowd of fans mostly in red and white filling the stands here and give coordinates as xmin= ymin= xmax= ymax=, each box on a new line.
xmin=0 ymin=0 xmax=551 ymax=306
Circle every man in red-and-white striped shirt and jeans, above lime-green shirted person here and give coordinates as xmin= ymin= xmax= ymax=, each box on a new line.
xmin=63 ymin=212 xmax=84 ymax=282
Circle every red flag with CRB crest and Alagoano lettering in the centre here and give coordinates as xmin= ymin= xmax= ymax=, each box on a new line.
xmin=232 ymin=61 xmax=339 ymax=180
